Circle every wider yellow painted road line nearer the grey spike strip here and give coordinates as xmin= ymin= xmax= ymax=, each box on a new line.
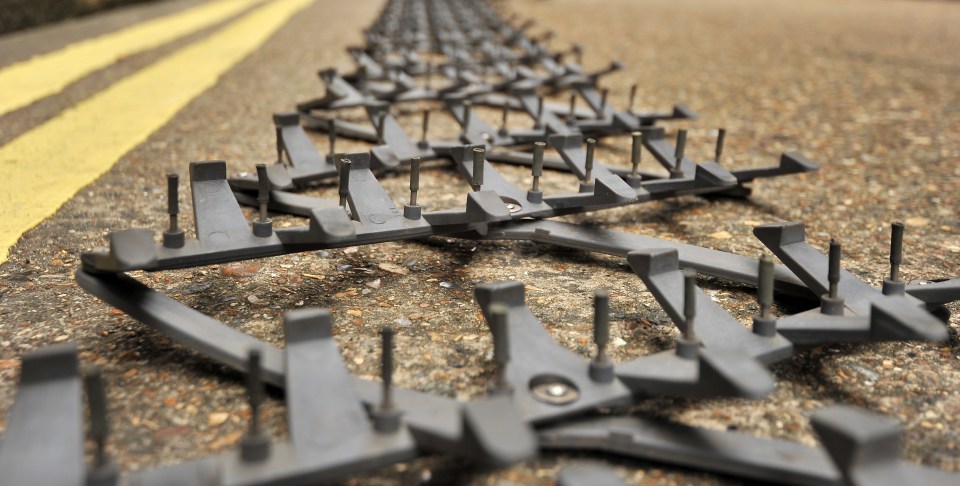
xmin=0 ymin=0 xmax=313 ymax=263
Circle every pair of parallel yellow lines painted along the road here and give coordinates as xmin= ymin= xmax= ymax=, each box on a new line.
xmin=0 ymin=0 xmax=313 ymax=263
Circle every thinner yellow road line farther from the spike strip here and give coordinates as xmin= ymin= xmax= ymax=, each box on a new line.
xmin=0 ymin=0 xmax=261 ymax=115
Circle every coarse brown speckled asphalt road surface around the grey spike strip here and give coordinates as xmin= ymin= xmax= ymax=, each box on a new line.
xmin=0 ymin=0 xmax=960 ymax=484
